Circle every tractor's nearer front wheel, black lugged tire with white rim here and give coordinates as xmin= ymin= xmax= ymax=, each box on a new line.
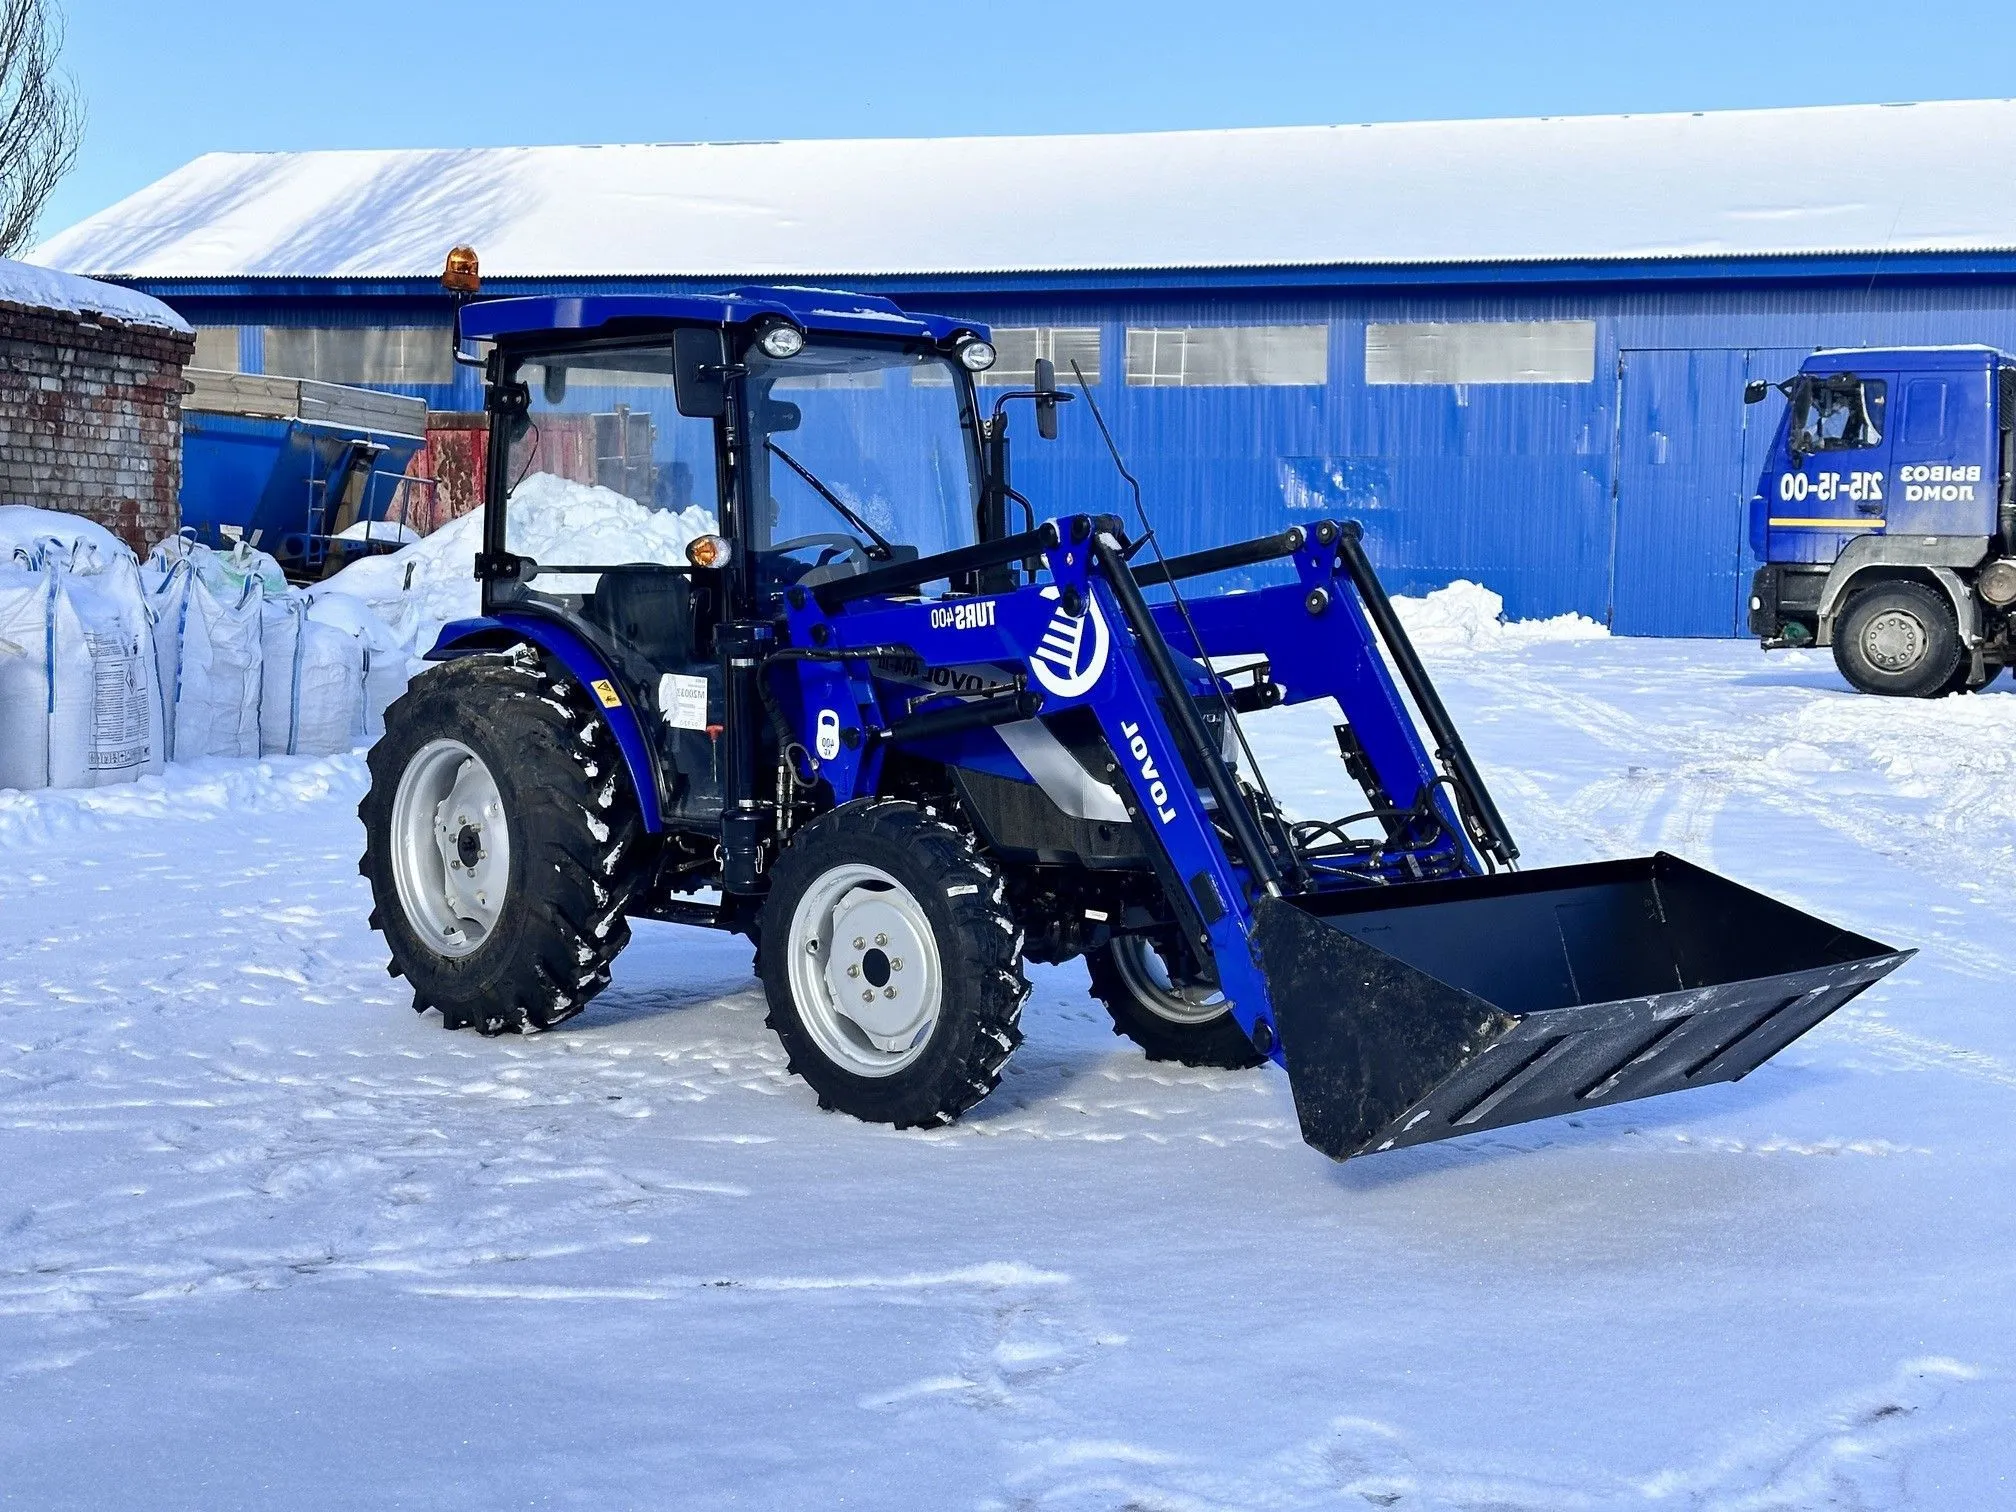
xmin=756 ymin=798 xmax=1028 ymax=1129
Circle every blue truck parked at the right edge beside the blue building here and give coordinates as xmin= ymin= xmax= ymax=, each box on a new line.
xmin=1744 ymin=347 xmax=2016 ymax=698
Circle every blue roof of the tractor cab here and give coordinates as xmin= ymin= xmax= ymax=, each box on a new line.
xmin=462 ymin=284 xmax=988 ymax=341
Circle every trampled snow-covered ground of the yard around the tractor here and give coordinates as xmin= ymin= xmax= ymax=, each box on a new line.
xmin=0 ymin=641 xmax=2016 ymax=1512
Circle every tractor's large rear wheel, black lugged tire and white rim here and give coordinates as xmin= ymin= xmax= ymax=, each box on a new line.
xmin=357 ymin=647 xmax=645 ymax=1034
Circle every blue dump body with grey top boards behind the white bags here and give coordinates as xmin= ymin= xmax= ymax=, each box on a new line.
xmin=181 ymin=367 xmax=433 ymax=579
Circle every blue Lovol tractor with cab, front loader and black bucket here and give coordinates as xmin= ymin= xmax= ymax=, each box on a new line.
xmin=361 ymin=276 xmax=1905 ymax=1159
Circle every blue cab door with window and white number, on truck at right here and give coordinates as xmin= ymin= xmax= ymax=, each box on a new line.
xmin=1764 ymin=371 xmax=1897 ymax=562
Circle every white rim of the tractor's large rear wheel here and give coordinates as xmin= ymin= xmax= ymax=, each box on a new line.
xmin=391 ymin=740 xmax=510 ymax=956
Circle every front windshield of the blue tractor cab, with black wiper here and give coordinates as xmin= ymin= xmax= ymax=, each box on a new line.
xmin=744 ymin=341 xmax=978 ymax=562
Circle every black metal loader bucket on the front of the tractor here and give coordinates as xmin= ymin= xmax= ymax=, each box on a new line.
xmin=1254 ymin=853 xmax=1913 ymax=1159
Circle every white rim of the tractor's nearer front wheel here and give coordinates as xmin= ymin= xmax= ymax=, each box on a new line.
xmin=786 ymin=865 xmax=946 ymax=1077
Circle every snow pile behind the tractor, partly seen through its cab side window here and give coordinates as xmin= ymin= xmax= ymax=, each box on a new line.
xmin=317 ymin=472 xmax=720 ymax=653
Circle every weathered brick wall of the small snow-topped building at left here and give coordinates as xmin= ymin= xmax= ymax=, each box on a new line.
xmin=0 ymin=302 xmax=196 ymax=554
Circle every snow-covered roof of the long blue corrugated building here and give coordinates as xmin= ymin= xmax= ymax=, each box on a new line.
xmin=32 ymin=101 xmax=2016 ymax=278
